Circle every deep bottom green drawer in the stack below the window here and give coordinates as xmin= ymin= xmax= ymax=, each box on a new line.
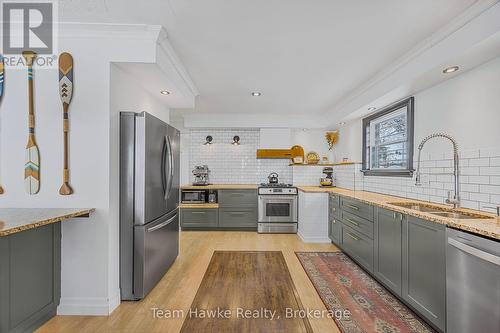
xmin=342 ymin=224 xmax=373 ymax=272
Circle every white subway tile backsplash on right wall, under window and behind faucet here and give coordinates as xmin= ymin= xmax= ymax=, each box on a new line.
xmin=335 ymin=148 xmax=500 ymax=210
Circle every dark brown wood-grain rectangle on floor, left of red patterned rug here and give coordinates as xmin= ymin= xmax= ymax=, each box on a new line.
xmin=181 ymin=251 xmax=312 ymax=333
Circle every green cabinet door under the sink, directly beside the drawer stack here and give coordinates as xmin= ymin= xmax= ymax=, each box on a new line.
xmin=373 ymin=208 xmax=406 ymax=296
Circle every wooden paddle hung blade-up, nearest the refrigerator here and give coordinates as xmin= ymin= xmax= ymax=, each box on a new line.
xmin=59 ymin=52 xmax=73 ymax=195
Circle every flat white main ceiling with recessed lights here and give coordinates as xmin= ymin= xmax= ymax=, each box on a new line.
xmin=59 ymin=0 xmax=476 ymax=115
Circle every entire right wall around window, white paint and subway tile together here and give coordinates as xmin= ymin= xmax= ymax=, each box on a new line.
xmin=337 ymin=58 xmax=500 ymax=210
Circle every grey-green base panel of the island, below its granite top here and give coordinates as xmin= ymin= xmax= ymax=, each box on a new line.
xmin=0 ymin=223 xmax=61 ymax=333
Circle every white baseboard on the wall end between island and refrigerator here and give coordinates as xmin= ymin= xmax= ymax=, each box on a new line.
xmin=57 ymin=290 xmax=120 ymax=316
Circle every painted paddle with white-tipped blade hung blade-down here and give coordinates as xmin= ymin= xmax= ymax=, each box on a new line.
xmin=23 ymin=51 xmax=40 ymax=194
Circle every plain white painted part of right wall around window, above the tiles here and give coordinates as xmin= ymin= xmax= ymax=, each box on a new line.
xmin=336 ymin=58 xmax=500 ymax=162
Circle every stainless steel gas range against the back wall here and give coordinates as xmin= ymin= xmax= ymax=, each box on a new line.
xmin=258 ymin=183 xmax=298 ymax=233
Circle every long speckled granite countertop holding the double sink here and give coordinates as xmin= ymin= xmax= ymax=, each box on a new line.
xmin=298 ymin=186 xmax=500 ymax=240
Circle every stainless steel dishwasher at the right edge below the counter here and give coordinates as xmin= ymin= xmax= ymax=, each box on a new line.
xmin=446 ymin=228 xmax=500 ymax=333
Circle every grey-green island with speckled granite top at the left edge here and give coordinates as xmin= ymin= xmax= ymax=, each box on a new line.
xmin=0 ymin=208 xmax=94 ymax=333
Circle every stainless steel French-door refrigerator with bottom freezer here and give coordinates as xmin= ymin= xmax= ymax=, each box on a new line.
xmin=120 ymin=112 xmax=180 ymax=300
